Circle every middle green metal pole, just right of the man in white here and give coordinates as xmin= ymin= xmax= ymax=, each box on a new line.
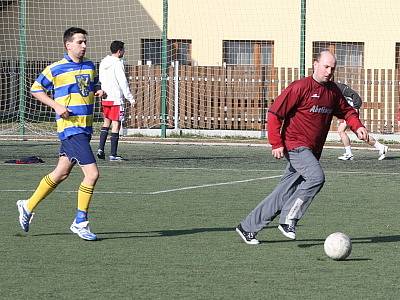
xmin=161 ymin=0 xmax=168 ymax=138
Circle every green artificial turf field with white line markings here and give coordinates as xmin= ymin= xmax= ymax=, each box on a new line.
xmin=0 ymin=141 xmax=400 ymax=299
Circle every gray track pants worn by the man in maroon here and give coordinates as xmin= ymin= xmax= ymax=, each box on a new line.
xmin=241 ymin=147 xmax=325 ymax=232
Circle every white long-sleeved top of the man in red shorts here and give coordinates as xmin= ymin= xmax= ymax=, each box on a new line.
xmin=99 ymin=55 xmax=135 ymax=105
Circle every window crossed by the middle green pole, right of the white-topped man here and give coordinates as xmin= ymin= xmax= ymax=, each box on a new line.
xmin=141 ymin=39 xmax=192 ymax=65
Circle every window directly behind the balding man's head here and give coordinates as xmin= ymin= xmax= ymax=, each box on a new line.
xmin=313 ymin=42 xmax=364 ymax=68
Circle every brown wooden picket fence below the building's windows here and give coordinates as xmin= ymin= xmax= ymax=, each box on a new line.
xmin=127 ymin=66 xmax=400 ymax=133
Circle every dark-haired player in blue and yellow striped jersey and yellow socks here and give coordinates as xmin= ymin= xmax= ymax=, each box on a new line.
xmin=17 ymin=27 xmax=104 ymax=241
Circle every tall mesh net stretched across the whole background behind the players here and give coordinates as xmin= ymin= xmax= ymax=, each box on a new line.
xmin=0 ymin=0 xmax=400 ymax=137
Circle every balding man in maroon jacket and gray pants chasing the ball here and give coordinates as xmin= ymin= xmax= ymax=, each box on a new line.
xmin=236 ymin=50 xmax=368 ymax=245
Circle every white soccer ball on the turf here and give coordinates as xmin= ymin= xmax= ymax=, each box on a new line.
xmin=324 ymin=232 xmax=351 ymax=260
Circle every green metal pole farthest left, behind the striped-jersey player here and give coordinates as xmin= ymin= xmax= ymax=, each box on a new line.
xmin=19 ymin=0 xmax=26 ymax=137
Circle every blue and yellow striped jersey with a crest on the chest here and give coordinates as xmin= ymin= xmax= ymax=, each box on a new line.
xmin=31 ymin=54 xmax=98 ymax=140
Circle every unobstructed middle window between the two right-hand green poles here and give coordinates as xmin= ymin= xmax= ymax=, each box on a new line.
xmin=222 ymin=41 xmax=274 ymax=66
